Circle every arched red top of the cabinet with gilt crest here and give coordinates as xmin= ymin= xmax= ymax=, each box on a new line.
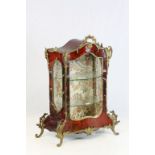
xmin=46 ymin=35 xmax=112 ymax=63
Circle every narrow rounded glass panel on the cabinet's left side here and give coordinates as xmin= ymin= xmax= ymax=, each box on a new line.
xmin=53 ymin=60 xmax=63 ymax=112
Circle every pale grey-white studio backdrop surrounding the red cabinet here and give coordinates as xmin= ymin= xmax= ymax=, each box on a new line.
xmin=27 ymin=0 xmax=129 ymax=155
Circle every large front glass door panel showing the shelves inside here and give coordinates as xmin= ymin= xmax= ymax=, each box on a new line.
xmin=70 ymin=54 xmax=103 ymax=120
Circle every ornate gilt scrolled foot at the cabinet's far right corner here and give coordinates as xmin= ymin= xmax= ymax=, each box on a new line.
xmin=108 ymin=111 xmax=120 ymax=135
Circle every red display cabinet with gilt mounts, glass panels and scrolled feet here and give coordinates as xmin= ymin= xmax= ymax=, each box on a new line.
xmin=36 ymin=35 xmax=119 ymax=146
